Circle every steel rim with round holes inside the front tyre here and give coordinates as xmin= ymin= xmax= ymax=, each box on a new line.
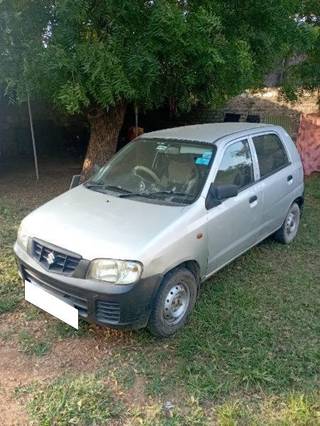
xmin=162 ymin=283 xmax=190 ymax=325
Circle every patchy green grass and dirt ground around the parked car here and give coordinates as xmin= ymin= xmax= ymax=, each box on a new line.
xmin=0 ymin=161 xmax=320 ymax=425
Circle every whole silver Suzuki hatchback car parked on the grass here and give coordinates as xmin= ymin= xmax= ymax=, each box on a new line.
xmin=15 ymin=123 xmax=304 ymax=336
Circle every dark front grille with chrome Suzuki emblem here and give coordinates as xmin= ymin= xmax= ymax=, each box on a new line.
xmin=32 ymin=240 xmax=81 ymax=275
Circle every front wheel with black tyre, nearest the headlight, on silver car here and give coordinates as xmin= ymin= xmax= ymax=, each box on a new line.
xmin=148 ymin=267 xmax=198 ymax=337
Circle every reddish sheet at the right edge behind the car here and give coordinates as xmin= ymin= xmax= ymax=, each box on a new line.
xmin=297 ymin=114 xmax=320 ymax=176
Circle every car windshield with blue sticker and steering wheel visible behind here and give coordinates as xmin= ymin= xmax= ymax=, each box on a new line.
xmin=86 ymin=138 xmax=216 ymax=205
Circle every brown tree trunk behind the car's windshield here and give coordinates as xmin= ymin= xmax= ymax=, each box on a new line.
xmin=81 ymin=104 xmax=126 ymax=180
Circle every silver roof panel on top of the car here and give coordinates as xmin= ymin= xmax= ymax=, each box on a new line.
xmin=141 ymin=122 xmax=277 ymax=143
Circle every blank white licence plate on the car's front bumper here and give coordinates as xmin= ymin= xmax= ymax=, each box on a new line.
xmin=25 ymin=281 xmax=79 ymax=330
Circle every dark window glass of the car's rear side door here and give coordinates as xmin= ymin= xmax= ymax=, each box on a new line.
xmin=252 ymin=133 xmax=289 ymax=177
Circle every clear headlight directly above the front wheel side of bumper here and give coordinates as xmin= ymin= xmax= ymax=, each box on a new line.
xmin=87 ymin=259 xmax=142 ymax=284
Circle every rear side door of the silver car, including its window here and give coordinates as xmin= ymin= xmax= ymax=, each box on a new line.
xmin=252 ymin=132 xmax=295 ymax=237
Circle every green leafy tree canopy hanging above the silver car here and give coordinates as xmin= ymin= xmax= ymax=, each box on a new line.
xmin=0 ymin=0 xmax=310 ymax=114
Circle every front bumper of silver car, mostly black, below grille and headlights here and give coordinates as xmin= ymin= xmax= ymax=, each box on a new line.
xmin=14 ymin=244 xmax=162 ymax=329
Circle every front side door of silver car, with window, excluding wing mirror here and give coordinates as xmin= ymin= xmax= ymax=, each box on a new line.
xmin=207 ymin=139 xmax=263 ymax=275
